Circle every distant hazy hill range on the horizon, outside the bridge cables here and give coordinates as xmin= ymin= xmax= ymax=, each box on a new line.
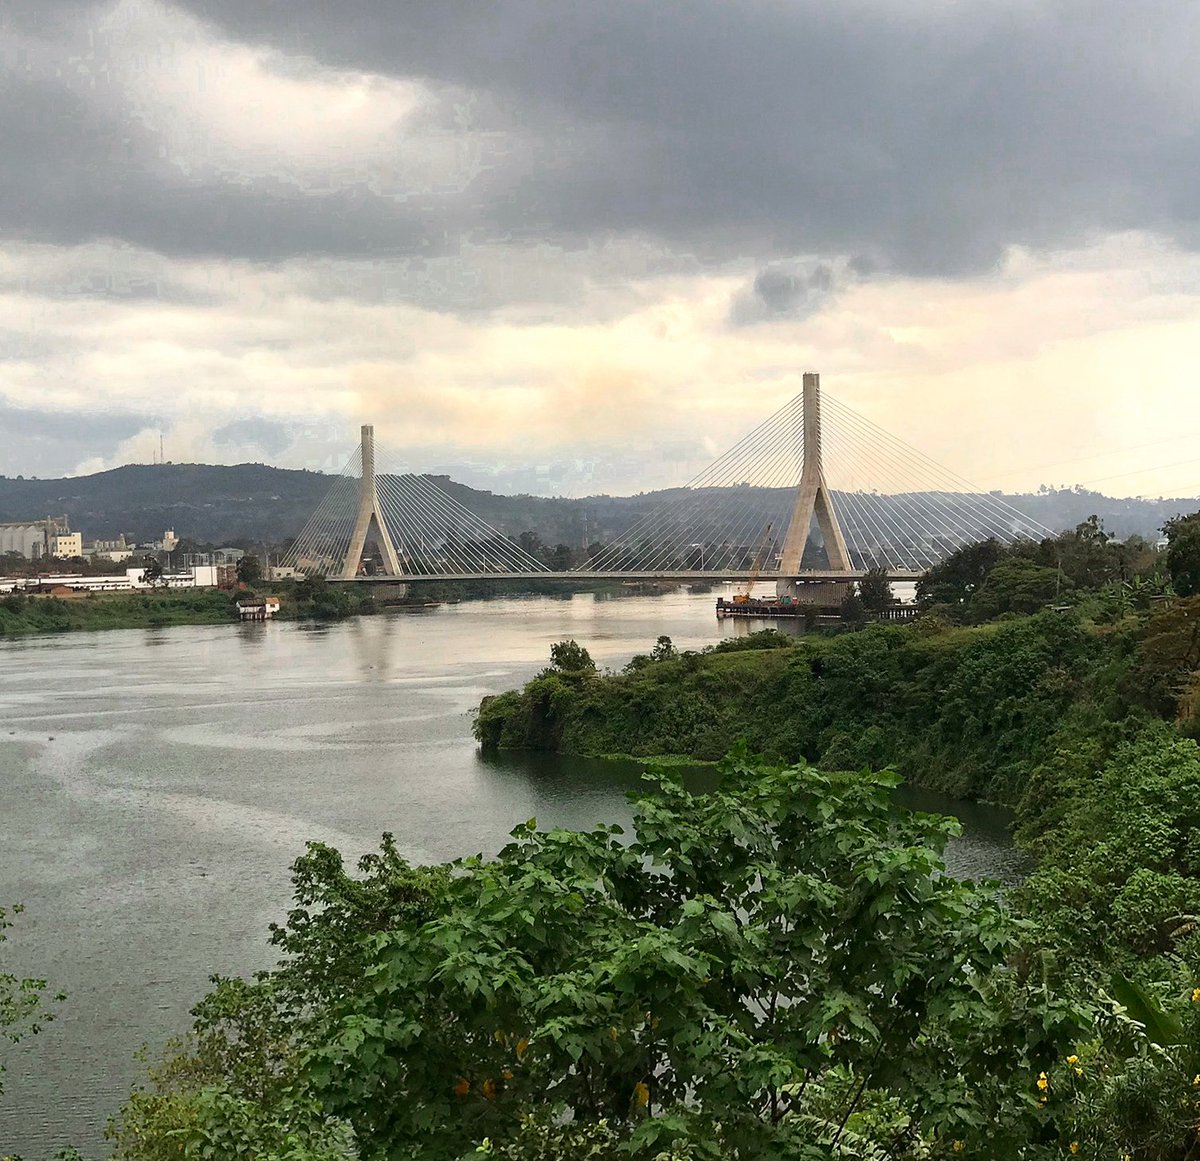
xmin=0 ymin=464 xmax=1200 ymax=546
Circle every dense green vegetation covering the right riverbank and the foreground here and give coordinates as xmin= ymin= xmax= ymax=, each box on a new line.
xmin=11 ymin=517 xmax=1200 ymax=1161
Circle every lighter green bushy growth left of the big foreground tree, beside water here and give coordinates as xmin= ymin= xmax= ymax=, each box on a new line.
xmin=109 ymin=835 xmax=445 ymax=1161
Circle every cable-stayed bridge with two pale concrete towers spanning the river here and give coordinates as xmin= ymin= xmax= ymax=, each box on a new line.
xmin=281 ymin=373 xmax=1052 ymax=600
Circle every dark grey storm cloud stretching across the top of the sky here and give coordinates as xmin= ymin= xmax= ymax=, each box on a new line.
xmin=7 ymin=0 xmax=1200 ymax=273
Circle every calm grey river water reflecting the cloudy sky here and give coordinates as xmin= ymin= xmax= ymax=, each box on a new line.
xmin=0 ymin=591 xmax=1020 ymax=1159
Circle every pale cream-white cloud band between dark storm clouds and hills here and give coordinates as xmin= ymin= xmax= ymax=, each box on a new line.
xmin=0 ymin=235 xmax=1200 ymax=494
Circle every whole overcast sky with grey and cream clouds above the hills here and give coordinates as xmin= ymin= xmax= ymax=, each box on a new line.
xmin=0 ymin=0 xmax=1200 ymax=495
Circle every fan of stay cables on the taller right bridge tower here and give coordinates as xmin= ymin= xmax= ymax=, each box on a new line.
xmin=581 ymin=395 xmax=1052 ymax=573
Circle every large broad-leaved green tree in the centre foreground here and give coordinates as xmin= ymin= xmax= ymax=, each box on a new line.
xmin=292 ymin=758 xmax=1082 ymax=1159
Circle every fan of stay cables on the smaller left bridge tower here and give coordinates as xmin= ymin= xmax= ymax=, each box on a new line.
xmin=282 ymin=447 xmax=546 ymax=577
